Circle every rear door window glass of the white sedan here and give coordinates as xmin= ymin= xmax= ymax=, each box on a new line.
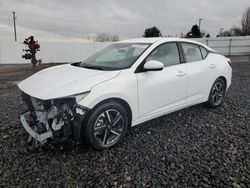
xmin=181 ymin=43 xmax=202 ymax=62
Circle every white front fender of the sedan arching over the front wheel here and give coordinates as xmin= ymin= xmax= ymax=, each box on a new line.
xmin=78 ymin=69 xmax=138 ymax=121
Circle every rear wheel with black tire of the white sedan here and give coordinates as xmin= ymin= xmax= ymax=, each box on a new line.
xmin=207 ymin=78 xmax=226 ymax=108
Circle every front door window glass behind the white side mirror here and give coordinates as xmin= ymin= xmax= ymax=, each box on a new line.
xmin=146 ymin=43 xmax=180 ymax=67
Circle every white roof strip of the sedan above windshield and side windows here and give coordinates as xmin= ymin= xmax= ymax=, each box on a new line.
xmin=118 ymin=37 xmax=214 ymax=51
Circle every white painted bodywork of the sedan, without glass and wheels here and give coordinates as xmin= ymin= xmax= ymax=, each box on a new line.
xmin=19 ymin=38 xmax=232 ymax=126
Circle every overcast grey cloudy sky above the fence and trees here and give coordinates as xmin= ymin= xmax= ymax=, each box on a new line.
xmin=0 ymin=0 xmax=250 ymax=41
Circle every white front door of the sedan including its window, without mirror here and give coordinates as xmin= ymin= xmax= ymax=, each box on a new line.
xmin=137 ymin=42 xmax=187 ymax=117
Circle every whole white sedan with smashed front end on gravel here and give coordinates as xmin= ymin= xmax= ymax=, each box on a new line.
xmin=18 ymin=38 xmax=232 ymax=150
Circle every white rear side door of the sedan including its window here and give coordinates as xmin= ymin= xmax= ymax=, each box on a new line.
xmin=181 ymin=42 xmax=215 ymax=103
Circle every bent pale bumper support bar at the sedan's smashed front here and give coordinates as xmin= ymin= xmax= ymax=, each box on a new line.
xmin=20 ymin=112 xmax=53 ymax=144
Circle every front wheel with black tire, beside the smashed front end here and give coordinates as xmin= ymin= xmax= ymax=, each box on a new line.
xmin=83 ymin=101 xmax=129 ymax=150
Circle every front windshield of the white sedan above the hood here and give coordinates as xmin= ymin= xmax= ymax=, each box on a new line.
xmin=79 ymin=43 xmax=149 ymax=70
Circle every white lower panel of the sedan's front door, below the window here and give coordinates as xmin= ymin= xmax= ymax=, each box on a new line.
xmin=137 ymin=64 xmax=187 ymax=117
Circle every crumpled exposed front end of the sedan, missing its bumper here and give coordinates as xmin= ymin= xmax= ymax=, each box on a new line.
xmin=20 ymin=92 xmax=88 ymax=147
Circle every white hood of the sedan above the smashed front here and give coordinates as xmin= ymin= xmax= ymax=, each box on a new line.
xmin=18 ymin=64 xmax=120 ymax=100
